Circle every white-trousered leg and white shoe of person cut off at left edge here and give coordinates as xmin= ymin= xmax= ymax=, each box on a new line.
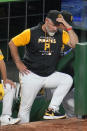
xmin=0 ymin=84 xmax=20 ymax=125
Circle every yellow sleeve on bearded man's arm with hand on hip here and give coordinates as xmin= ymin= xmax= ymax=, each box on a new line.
xmin=12 ymin=29 xmax=31 ymax=46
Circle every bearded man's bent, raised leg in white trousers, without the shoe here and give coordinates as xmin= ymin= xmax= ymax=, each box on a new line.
xmin=44 ymin=72 xmax=73 ymax=118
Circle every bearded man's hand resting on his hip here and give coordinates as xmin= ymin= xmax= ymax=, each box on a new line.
xmin=16 ymin=61 xmax=29 ymax=75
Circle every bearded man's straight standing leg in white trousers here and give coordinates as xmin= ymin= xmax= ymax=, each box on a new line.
xmin=18 ymin=72 xmax=43 ymax=123
